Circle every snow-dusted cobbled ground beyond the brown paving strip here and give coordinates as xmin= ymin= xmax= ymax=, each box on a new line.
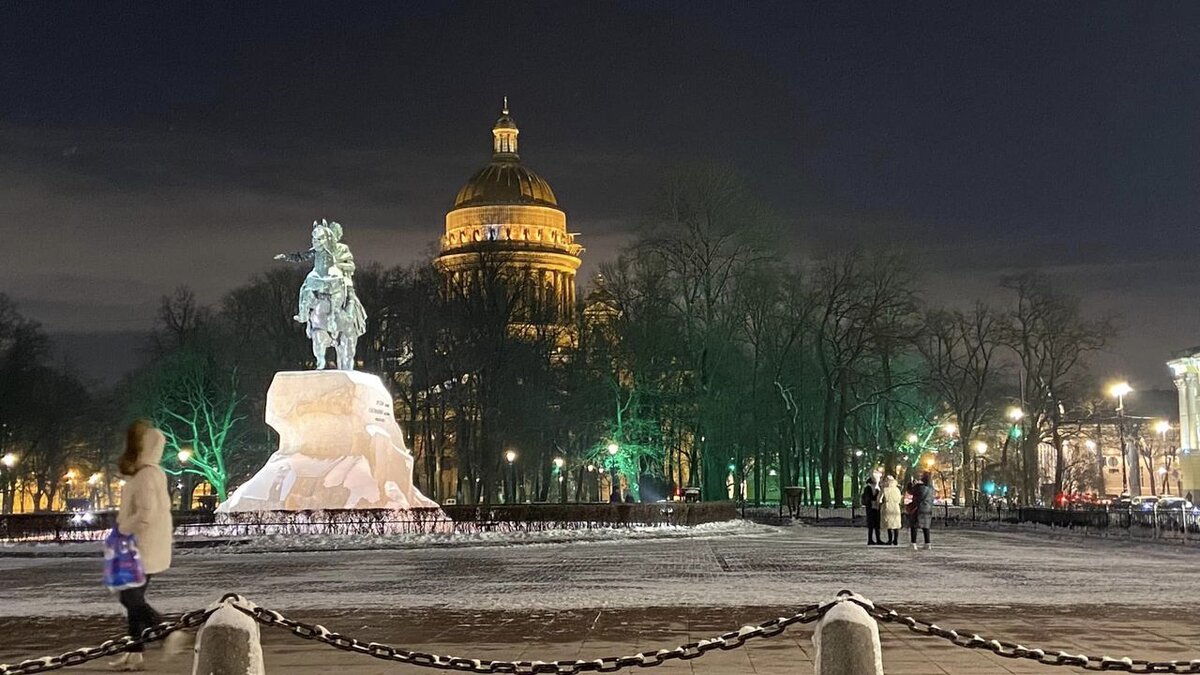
xmin=0 ymin=525 xmax=1200 ymax=616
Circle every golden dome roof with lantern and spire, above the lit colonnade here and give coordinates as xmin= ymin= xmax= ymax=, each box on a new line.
xmin=454 ymin=97 xmax=558 ymax=209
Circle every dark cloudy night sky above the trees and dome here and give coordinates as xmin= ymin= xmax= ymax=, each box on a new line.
xmin=0 ymin=0 xmax=1200 ymax=387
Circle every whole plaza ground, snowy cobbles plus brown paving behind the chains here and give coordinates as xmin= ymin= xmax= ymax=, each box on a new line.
xmin=0 ymin=524 xmax=1200 ymax=674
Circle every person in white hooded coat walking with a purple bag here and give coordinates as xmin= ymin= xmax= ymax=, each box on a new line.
xmin=109 ymin=419 xmax=175 ymax=670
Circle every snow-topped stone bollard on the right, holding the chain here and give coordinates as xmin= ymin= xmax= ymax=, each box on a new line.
xmin=812 ymin=595 xmax=883 ymax=675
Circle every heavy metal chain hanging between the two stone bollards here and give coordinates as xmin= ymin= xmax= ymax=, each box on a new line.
xmin=225 ymin=598 xmax=840 ymax=675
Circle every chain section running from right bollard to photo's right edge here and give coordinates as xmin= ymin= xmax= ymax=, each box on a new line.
xmin=841 ymin=591 xmax=1200 ymax=673
